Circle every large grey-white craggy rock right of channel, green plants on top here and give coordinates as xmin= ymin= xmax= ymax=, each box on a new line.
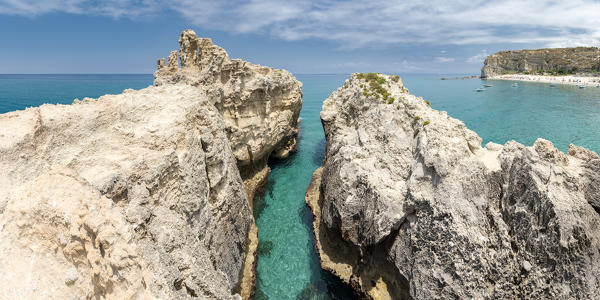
xmin=306 ymin=74 xmax=600 ymax=299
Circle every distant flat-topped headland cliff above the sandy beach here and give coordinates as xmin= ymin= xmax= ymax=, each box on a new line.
xmin=481 ymin=47 xmax=600 ymax=78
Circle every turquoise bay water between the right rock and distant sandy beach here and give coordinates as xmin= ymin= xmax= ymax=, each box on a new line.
xmin=403 ymin=75 xmax=600 ymax=152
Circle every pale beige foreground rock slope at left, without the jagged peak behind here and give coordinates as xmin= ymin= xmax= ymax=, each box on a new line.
xmin=0 ymin=85 xmax=253 ymax=299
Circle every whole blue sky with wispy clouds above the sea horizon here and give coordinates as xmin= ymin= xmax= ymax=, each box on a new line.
xmin=0 ymin=0 xmax=600 ymax=74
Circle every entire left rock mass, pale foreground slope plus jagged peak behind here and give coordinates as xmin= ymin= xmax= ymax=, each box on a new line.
xmin=0 ymin=30 xmax=302 ymax=299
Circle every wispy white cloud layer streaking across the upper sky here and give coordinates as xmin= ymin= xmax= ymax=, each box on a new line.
xmin=0 ymin=0 xmax=600 ymax=48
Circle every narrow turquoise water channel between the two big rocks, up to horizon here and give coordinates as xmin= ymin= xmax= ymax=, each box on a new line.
xmin=254 ymin=75 xmax=352 ymax=300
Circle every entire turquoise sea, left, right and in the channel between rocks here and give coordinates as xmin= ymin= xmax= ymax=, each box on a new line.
xmin=0 ymin=74 xmax=600 ymax=299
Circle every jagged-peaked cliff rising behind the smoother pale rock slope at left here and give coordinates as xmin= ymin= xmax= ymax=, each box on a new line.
xmin=154 ymin=30 xmax=302 ymax=178
